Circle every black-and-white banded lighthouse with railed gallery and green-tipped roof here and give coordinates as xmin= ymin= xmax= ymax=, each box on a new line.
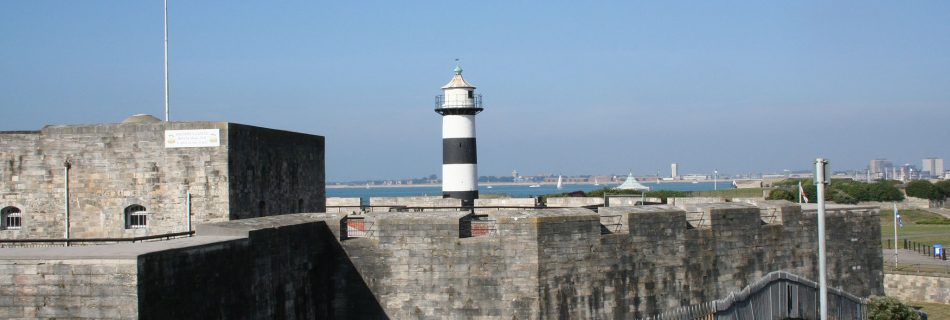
xmin=435 ymin=65 xmax=482 ymax=206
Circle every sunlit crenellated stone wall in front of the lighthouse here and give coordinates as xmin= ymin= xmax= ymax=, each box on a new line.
xmin=343 ymin=202 xmax=883 ymax=318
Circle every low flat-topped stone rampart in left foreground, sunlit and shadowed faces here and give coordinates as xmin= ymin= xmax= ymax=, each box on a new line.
xmin=0 ymin=214 xmax=360 ymax=319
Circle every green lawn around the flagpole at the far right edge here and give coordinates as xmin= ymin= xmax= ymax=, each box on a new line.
xmin=881 ymin=210 xmax=950 ymax=248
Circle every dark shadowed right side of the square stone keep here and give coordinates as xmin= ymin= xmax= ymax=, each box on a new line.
xmin=228 ymin=123 xmax=326 ymax=219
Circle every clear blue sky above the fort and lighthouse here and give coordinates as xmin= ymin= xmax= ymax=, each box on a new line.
xmin=0 ymin=0 xmax=950 ymax=181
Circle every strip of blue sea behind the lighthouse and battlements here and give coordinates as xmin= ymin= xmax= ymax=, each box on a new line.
xmin=327 ymin=181 xmax=734 ymax=198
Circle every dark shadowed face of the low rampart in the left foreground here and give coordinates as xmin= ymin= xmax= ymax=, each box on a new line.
xmin=138 ymin=222 xmax=388 ymax=319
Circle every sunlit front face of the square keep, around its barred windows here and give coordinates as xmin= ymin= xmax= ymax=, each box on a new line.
xmin=0 ymin=122 xmax=229 ymax=239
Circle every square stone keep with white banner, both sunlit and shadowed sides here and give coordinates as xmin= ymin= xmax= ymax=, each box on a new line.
xmin=0 ymin=115 xmax=325 ymax=239
